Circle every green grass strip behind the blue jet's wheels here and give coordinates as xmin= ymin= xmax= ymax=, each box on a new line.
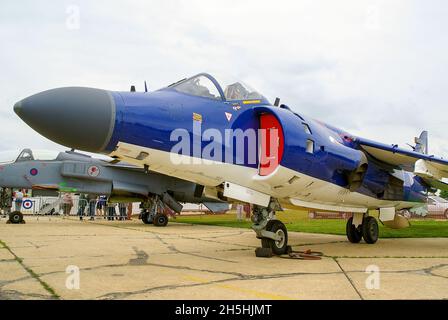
xmin=175 ymin=210 xmax=448 ymax=238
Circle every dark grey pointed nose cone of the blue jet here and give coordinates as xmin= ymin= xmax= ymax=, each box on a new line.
xmin=14 ymin=87 xmax=115 ymax=152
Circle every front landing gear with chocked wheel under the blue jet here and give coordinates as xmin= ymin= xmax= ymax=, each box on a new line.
xmin=252 ymin=200 xmax=288 ymax=257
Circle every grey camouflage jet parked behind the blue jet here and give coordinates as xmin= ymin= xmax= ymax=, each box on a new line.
xmin=0 ymin=149 xmax=229 ymax=226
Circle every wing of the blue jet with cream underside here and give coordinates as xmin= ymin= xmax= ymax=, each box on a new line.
xmin=353 ymin=137 xmax=448 ymax=180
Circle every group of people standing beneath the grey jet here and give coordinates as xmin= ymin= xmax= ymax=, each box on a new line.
xmin=62 ymin=193 xmax=132 ymax=220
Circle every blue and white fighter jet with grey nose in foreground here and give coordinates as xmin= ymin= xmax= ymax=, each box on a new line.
xmin=14 ymin=73 xmax=448 ymax=254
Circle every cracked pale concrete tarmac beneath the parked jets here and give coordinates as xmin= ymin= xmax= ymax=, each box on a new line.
xmin=0 ymin=217 xmax=448 ymax=299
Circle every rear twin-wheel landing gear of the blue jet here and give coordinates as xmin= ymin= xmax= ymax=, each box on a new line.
xmin=346 ymin=213 xmax=379 ymax=244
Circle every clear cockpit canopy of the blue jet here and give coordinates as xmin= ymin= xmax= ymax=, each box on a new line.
xmin=169 ymin=73 xmax=269 ymax=103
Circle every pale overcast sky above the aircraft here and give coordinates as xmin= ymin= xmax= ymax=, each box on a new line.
xmin=0 ymin=0 xmax=448 ymax=158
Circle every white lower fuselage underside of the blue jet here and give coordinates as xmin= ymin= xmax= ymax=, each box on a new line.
xmin=110 ymin=142 xmax=421 ymax=211
